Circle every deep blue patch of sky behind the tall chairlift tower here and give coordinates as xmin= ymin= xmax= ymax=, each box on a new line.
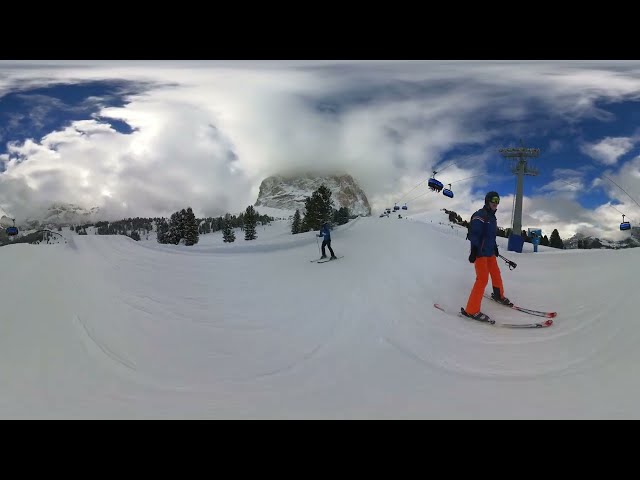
xmin=436 ymin=96 xmax=640 ymax=210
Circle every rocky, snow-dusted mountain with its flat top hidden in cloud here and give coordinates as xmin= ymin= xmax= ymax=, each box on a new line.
xmin=254 ymin=173 xmax=371 ymax=216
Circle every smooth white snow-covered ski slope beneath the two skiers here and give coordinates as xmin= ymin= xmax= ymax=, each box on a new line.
xmin=0 ymin=217 xmax=640 ymax=418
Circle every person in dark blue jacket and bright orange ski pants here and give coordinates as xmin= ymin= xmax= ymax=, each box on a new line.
xmin=462 ymin=192 xmax=512 ymax=321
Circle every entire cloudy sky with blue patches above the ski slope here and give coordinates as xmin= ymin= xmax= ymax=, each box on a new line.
xmin=0 ymin=61 xmax=640 ymax=239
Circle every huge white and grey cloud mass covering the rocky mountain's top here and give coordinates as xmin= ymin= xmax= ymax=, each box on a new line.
xmin=0 ymin=61 xmax=640 ymax=231
